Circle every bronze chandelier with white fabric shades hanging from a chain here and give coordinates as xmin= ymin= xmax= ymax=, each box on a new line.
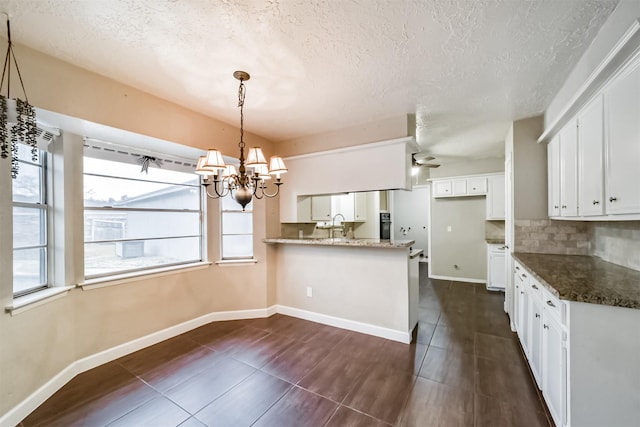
xmin=196 ymin=71 xmax=287 ymax=211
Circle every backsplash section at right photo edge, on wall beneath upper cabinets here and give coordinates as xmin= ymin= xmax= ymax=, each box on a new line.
xmin=591 ymin=221 xmax=640 ymax=271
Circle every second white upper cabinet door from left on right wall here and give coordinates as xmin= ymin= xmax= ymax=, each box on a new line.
xmin=560 ymin=119 xmax=578 ymax=216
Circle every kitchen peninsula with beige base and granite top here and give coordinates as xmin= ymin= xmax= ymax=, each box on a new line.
xmin=264 ymin=238 xmax=421 ymax=343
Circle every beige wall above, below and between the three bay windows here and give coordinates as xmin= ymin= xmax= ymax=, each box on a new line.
xmin=0 ymin=41 xmax=278 ymax=414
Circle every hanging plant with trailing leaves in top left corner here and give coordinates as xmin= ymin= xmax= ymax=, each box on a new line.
xmin=0 ymin=13 xmax=38 ymax=179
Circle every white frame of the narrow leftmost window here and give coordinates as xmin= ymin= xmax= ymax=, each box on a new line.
xmin=11 ymin=143 xmax=51 ymax=299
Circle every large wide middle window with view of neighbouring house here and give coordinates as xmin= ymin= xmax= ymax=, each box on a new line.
xmin=84 ymin=146 xmax=202 ymax=278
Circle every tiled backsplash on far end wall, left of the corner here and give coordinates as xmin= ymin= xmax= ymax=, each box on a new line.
xmin=513 ymin=219 xmax=591 ymax=255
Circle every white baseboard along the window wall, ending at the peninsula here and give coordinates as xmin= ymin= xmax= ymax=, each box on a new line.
xmin=0 ymin=306 xmax=277 ymax=426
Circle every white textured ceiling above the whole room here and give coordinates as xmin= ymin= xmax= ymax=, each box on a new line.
xmin=0 ymin=0 xmax=617 ymax=157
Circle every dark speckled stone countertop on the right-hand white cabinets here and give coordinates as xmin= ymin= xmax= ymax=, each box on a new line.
xmin=513 ymin=252 xmax=640 ymax=309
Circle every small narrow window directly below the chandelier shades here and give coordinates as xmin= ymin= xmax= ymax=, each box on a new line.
xmin=220 ymin=191 xmax=253 ymax=260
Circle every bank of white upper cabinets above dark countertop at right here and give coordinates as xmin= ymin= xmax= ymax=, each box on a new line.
xmin=547 ymin=57 xmax=640 ymax=220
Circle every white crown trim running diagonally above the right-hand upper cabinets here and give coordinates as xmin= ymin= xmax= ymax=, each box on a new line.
xmin=538 ymin=19 xmax=640 ymax=143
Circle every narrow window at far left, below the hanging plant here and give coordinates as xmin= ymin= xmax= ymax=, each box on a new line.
xmin=12 ymin=144 xmax=47 ymax=297
